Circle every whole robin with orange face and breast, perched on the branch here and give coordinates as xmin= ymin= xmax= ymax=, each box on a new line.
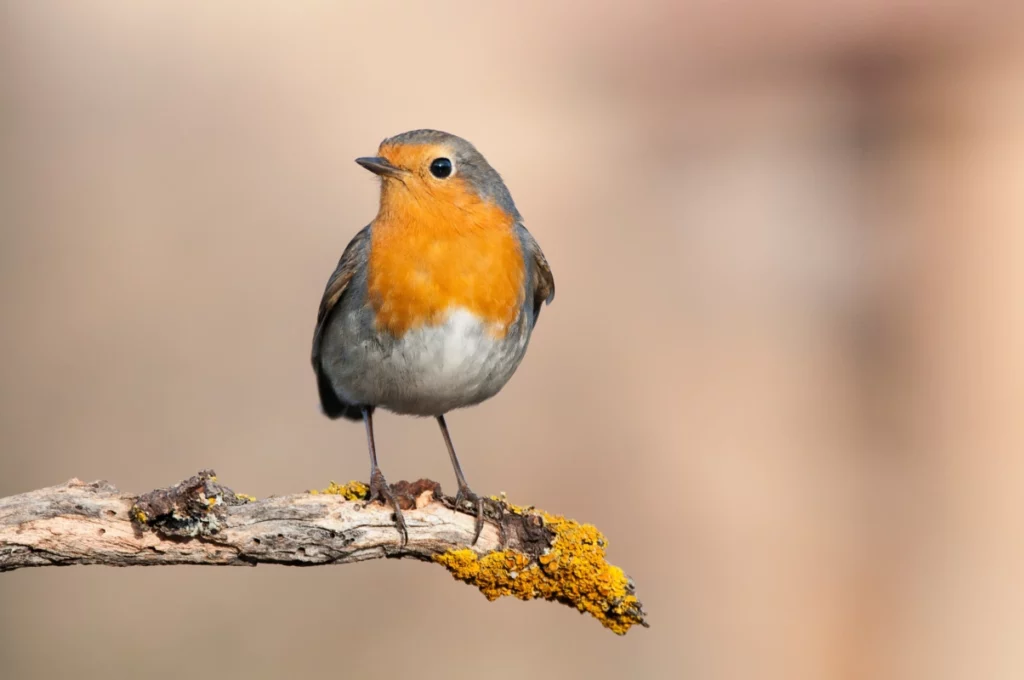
xmin=312 ymin=130 xmax=555 ymax=543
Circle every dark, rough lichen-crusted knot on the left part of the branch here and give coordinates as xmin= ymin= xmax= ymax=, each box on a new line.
xmin=130 ymin=470 xmax=249 ymax=538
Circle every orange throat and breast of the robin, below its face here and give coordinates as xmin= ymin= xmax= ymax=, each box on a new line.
xmin=368 ymin=182 xmax=525 ymax=337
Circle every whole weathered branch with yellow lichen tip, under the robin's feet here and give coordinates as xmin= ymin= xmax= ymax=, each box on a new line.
xmin=0 ymin=471 xmax=647 ymax=634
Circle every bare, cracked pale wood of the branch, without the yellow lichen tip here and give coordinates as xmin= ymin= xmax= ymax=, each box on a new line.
xmin=0 ymin=475 xmax=512 ymax=571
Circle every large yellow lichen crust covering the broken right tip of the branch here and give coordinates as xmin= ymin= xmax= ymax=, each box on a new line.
xmin=434 ymin=499 xmax=645 ymax=635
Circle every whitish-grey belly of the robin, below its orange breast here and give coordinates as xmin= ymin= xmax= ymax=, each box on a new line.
xmin=337 ymin=308 xmax=529 ymax=416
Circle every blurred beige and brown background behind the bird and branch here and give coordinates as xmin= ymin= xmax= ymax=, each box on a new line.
xmin=0 ymin=0 xmax=1024 ymax=679
